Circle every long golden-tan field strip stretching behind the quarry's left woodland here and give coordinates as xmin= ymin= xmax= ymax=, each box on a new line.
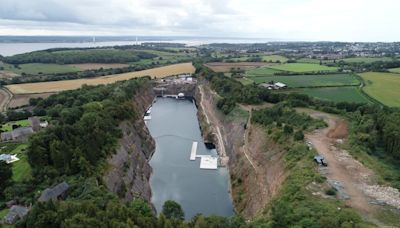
xmin=7 ymin=63 xmax=195 ymax=94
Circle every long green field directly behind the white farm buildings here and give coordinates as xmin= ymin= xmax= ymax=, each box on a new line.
xmin=251 ymin=74 xmax=360 ymax=88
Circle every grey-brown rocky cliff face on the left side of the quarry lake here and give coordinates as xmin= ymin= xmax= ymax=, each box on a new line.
xmin=103 ymin=84 xmax=155 ymax=201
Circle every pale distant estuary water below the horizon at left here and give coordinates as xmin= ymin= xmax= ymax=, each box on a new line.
xmin=0 ymin=36 xmax=271 ymax=56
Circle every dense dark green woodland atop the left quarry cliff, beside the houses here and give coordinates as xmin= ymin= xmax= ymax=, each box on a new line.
xmin=28 ymin=79 xmax=148 ymax=180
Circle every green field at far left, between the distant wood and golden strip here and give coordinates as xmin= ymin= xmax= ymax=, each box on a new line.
xmin=3 ymin=63 xmax=81 ymax=75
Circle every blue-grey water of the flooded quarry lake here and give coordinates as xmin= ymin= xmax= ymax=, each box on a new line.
xmin=147 ymin=98 xmax=234 ymax=219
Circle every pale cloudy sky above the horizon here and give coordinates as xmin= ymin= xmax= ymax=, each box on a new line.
xmin=0 ymin=0 xmax=400 ymax=41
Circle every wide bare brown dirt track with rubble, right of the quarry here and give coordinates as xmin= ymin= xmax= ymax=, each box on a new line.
xmin=300 ymin=110 xmax=400 ymax=223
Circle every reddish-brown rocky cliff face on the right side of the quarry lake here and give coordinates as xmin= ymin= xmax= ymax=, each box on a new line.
xmin=196 ymin=82 xmax=285 ymax=218
